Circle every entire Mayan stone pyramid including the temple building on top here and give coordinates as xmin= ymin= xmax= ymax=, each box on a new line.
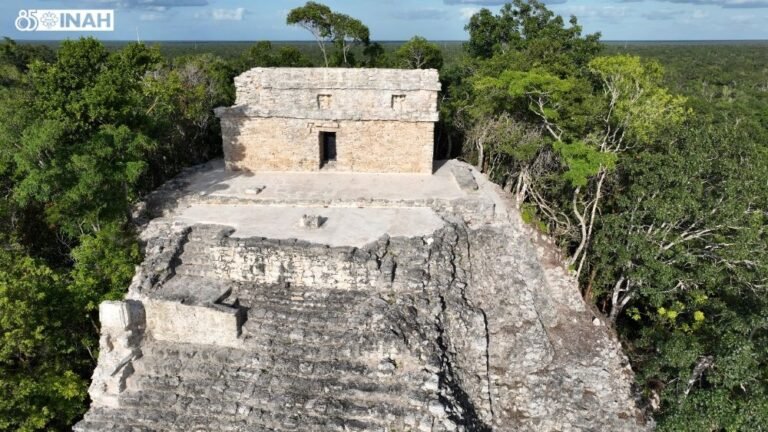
xmin=75 ymin=68 xmax=649 ymax=432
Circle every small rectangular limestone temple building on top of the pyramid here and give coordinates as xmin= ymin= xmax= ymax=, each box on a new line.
xmin=216 ymin=68 xmax=440 ymax=174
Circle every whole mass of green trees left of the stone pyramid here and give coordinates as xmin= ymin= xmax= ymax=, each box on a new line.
xmin=0 ymin=38 xmax=234 ymax=431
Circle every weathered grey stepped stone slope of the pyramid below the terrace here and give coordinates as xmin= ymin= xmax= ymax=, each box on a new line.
xmin=75 ymin=162 xmax=652 ymax=432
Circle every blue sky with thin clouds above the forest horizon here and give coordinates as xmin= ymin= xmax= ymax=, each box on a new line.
xmin=0 ymin=0 xmax=768 ymax=40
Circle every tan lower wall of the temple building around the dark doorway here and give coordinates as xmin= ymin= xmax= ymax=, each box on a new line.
xmin=222 ymin=117 xmax=434 ymax=174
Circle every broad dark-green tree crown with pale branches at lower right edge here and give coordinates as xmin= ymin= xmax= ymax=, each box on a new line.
xmin=590 ymin=118 xmax=768 ymax=430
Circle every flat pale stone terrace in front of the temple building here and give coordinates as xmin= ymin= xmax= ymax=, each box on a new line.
xmin=148 ymin=160 xmax=493 ymax=247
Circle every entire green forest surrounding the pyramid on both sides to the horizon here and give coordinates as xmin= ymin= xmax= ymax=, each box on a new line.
xmin=0 ymin=0 xmax=768 ymax=431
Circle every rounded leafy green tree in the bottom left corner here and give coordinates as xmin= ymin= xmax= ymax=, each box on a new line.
xmin=0 ymin=250 xmax=90 ymax=431
